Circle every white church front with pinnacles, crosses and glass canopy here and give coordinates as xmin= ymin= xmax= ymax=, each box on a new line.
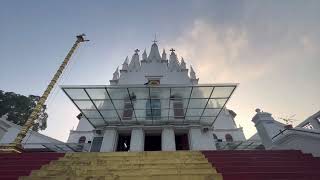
xmin=62 ymin=42 xmax=246 ymax=152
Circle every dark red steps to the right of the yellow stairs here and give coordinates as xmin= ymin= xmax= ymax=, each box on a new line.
xmin=203 ymin=150 xmax=320 ymax=180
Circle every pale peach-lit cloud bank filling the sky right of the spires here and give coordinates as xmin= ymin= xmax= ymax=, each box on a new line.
xmin=166 ymin=19 xmax=320 ymax=137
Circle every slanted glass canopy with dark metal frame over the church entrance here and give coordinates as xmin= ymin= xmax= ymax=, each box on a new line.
xmin=61 ymin=84 xmax=237 ymax=128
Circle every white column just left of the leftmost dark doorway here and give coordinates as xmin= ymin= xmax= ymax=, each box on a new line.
xmin=100 ymin=128 xmax=118 ymax=152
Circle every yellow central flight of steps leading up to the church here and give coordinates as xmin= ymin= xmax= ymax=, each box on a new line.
xmin=20 ymin=151 xmax=222 ymax=180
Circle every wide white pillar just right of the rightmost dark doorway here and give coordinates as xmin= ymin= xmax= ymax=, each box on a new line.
xmin=189 ymin=127 xmax=216 ymax=150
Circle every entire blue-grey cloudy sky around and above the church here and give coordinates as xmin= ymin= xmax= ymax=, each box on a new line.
xmin=0 ymin=0 xmax=320 ymax=141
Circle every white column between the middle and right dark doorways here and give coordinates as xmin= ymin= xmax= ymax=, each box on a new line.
xmin=161 ymin=128 xmax=176 ymax=151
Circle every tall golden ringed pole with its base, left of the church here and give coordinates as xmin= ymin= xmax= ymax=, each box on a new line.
xmin=0 ymin=34 xmax=89 ymax=153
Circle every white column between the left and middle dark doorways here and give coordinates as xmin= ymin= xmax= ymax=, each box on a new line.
xmin=130 ymin=128 xmax=144 ymax=152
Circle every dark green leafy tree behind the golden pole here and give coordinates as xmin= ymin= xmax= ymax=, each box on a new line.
xmin=0 ymin=90 xmax=48 ymax=131
